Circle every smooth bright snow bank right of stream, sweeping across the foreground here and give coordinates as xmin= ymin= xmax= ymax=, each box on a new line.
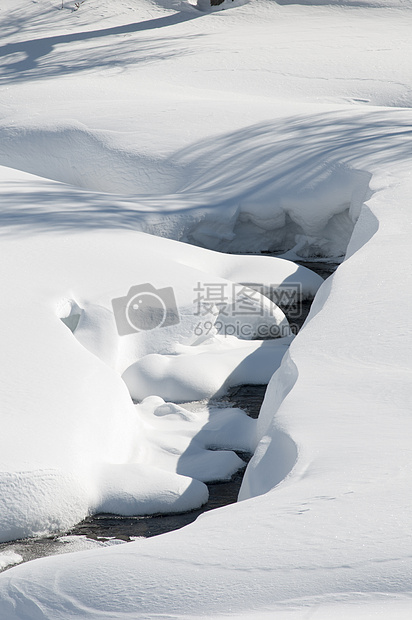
xmin=0 ymin=159 xmax=412 ymax=620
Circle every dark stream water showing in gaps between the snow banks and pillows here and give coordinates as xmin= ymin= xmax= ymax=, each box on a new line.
xmin=0 ymin=262 xmax=338 ymax=572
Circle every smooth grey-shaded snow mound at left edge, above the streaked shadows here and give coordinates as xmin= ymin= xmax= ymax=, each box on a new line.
xmin=0 ymin=123 xmax=181 ymax=194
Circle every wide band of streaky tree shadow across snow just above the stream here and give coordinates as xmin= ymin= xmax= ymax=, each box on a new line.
xmin=0 ymin=110 xmax=412 ymax=237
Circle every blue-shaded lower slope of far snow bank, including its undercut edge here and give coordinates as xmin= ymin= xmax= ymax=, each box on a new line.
xmin=0 ymin=114 xmax=374 ymax=258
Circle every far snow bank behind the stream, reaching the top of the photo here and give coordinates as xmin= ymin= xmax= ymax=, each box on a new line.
xmin=0 ymin=0 xmax=410 ymax=258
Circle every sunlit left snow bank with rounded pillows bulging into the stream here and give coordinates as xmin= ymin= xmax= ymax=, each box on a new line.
xmin=0 ymin=168 xmax=321 ymax=540
